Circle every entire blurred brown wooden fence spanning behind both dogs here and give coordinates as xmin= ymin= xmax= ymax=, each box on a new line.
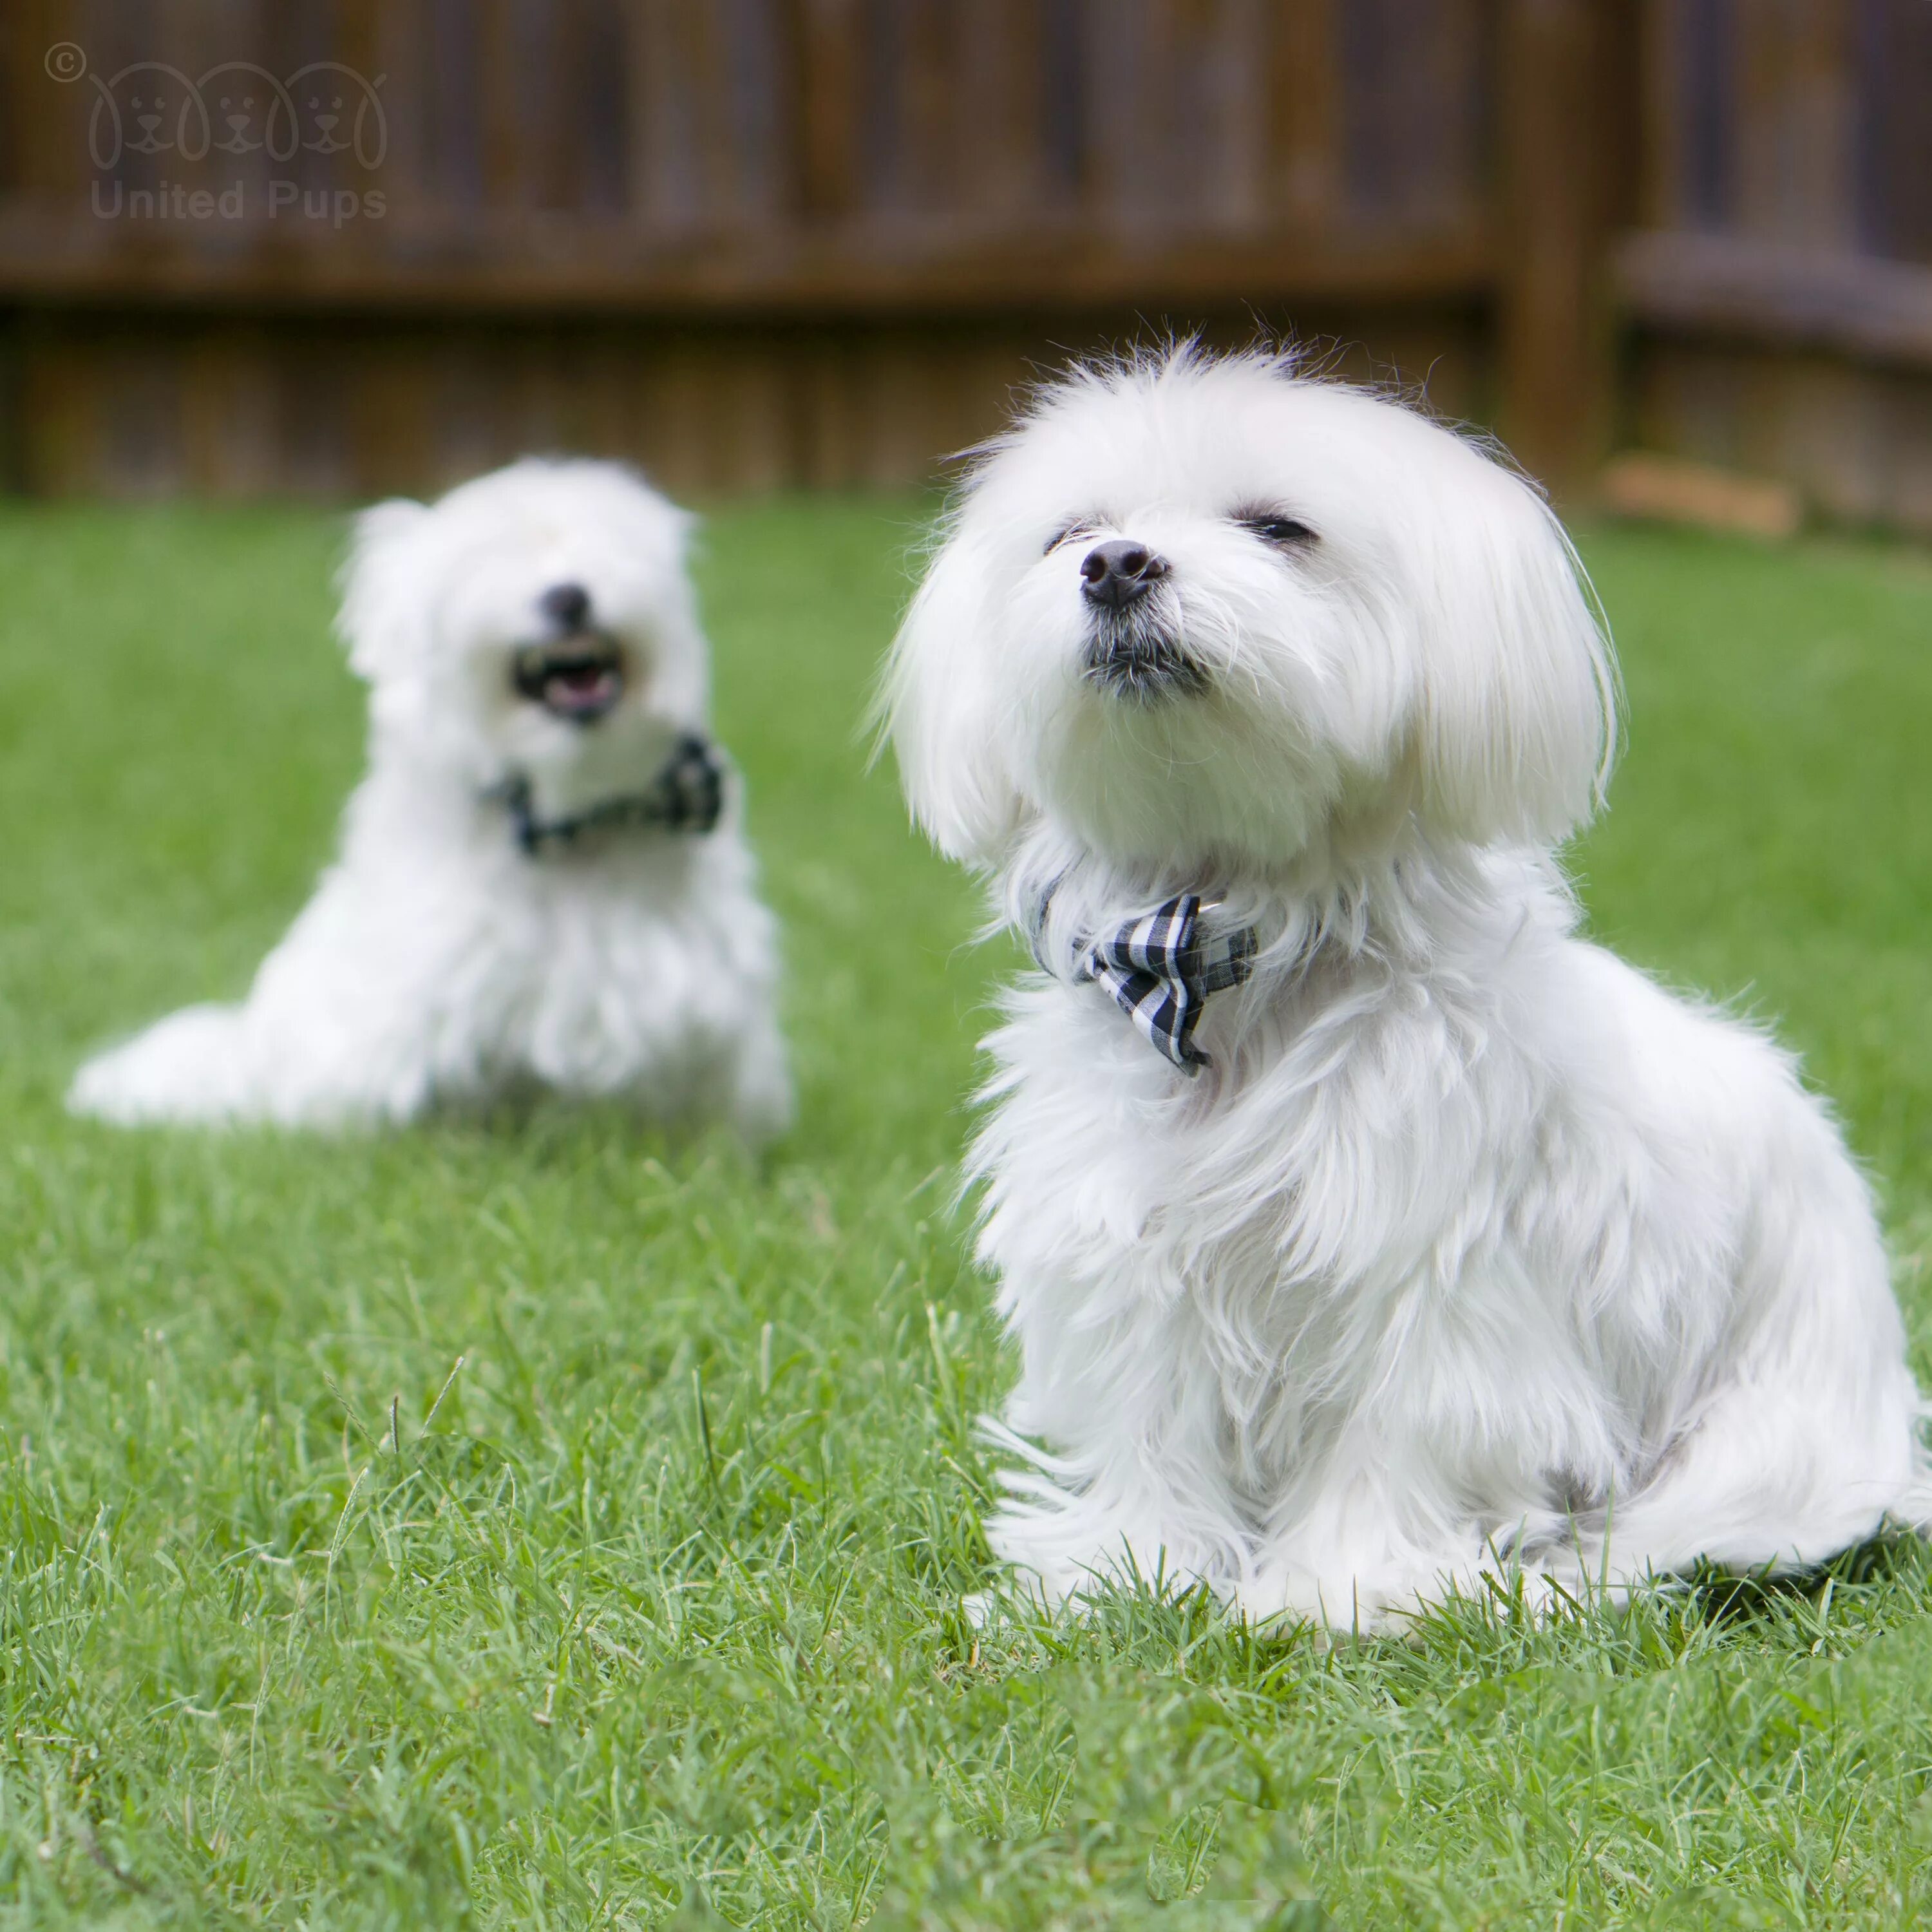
xmin=0 ymin=0 xmax=1932 ymax=529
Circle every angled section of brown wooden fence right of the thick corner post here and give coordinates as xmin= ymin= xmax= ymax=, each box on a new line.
xmin=1613 ymin=0 xmax=1932 ymax=533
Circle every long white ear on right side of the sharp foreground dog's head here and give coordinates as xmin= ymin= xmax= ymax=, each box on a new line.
xmin=1418 ymin=462 xmax=1617 ymax=844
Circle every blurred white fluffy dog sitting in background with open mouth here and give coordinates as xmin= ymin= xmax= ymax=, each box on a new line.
xmin=71 ymin=460 xmax=790 ymax=1140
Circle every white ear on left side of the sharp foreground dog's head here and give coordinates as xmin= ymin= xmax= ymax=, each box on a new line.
xmin=875 ymin=533 xmax=1022 ymax=866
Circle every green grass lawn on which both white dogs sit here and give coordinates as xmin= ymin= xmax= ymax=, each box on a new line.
xmin=0 ymin=500 xmax=1932 ymax=1932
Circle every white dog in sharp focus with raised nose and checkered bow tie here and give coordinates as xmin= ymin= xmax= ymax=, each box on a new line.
xmin=883 ymin=352 xmax=1932 ymax=1627
